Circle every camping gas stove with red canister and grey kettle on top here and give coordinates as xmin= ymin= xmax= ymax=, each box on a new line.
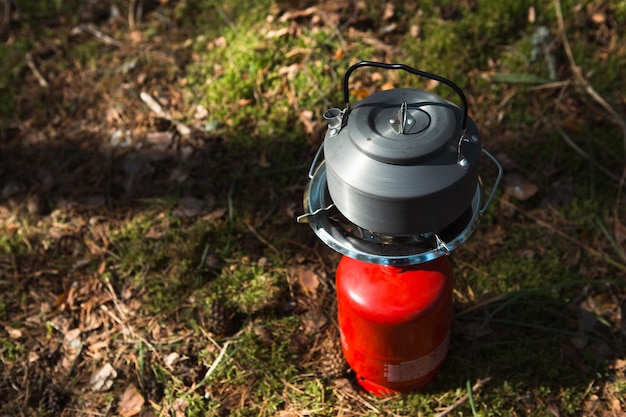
xmin=298 ymin=61 xmax=502 ymax=395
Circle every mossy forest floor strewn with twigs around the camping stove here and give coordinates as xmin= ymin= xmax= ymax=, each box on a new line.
xmin=0 ymin=0 xmax=626 ymax=417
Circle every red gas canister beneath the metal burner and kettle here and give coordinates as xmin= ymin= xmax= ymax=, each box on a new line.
xmin=336 ymin=256 xmax=452 ymax=395
